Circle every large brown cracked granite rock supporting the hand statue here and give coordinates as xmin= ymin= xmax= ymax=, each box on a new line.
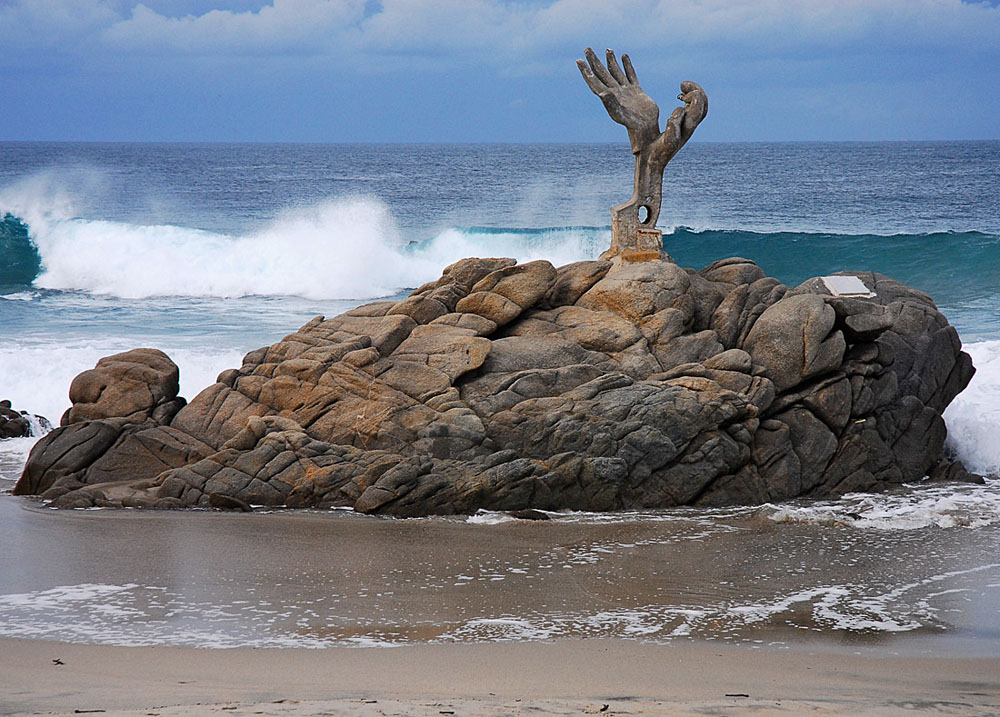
xmin=16 ymin=254 xmax=973 ymax=516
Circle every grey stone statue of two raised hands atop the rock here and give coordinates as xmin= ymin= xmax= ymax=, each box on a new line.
xmin=576 ymin=47 xmax=708 ymax=255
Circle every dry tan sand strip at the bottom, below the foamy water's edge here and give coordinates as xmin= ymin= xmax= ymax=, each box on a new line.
xmin=0 ymin=638 xmax=1000 ymax=715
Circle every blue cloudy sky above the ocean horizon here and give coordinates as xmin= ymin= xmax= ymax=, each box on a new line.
xmin=0 ymin=0 xmax=1000 ymax=142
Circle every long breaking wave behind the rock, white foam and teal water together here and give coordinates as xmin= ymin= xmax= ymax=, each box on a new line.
xmin=0 ymin=171 xmax=1000 ymax=310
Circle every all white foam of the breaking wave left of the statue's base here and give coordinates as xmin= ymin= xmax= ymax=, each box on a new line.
xmin=0 ymin=178 xmax=609 ymax=301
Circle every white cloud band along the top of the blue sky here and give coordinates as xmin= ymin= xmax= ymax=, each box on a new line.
xmin=0 ymin=0 xmax=1000 ymax=65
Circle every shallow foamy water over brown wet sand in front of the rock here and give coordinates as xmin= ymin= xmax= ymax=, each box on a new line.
xmin=0 ymin=495 xmax=1000 ymax=655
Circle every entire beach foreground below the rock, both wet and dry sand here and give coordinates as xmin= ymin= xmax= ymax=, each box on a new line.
xmin=0 ymin=496 xmax=1000 ymax=715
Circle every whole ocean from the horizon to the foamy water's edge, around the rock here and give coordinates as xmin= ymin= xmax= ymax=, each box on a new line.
xmin=0 ymin=142 xmax=1000 ymax=655
